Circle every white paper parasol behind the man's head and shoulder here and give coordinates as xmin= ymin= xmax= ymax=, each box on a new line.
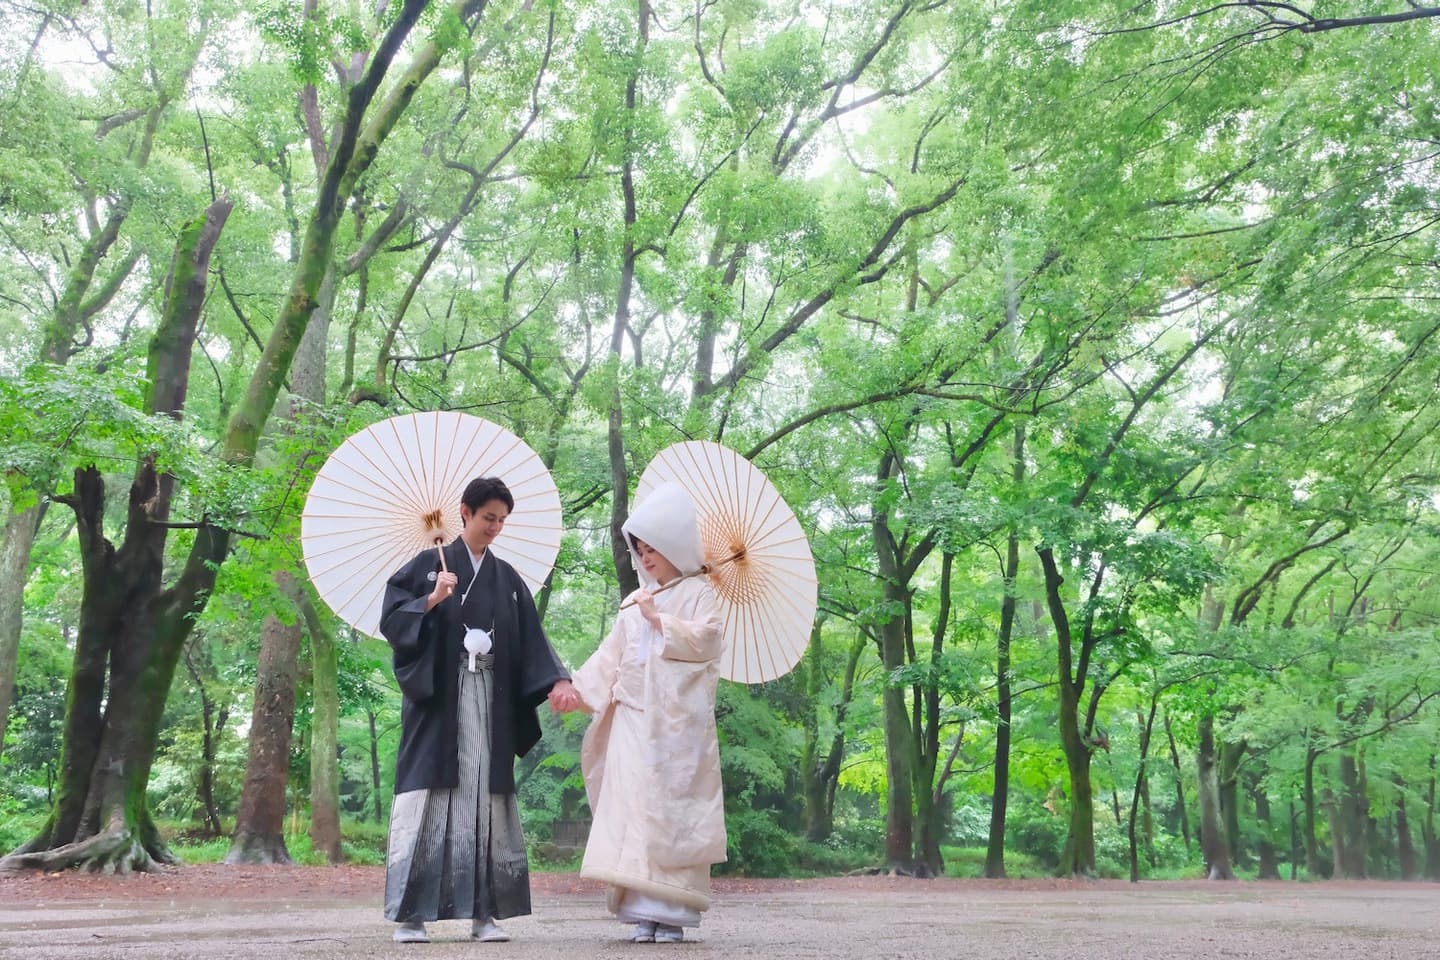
xmin=300 ymin=412 xmax=562 ymax=638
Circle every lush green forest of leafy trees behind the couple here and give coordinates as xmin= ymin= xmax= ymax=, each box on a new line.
xmin=0 ymin=0 xmax=1440 ymax=881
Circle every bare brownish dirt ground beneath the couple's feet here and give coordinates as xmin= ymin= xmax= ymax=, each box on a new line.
xmin=0 ymin=866 xmax=1440 ymax=960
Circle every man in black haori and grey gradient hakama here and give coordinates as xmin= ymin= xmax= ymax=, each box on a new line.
xmin=380 ymin=476 xmax=572 ymax=943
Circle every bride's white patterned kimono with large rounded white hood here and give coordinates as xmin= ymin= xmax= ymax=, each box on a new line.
xmin=572 ymin=484 xmax=726 ymax=927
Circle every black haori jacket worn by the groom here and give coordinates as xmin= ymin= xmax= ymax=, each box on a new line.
xmin=380 ymin=538 xmax=569 ymax=793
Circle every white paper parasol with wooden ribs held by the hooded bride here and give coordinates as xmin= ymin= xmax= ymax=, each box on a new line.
xmin=635 ymin=440 xmax=815 ymax=684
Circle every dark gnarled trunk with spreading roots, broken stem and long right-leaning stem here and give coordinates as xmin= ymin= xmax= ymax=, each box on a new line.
xmin=8 ymin=0 xmax=443 ymax=869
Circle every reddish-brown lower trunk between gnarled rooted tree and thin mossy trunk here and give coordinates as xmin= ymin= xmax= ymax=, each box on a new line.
xmin=225 ymin=573 xmax=301 ymax=864
